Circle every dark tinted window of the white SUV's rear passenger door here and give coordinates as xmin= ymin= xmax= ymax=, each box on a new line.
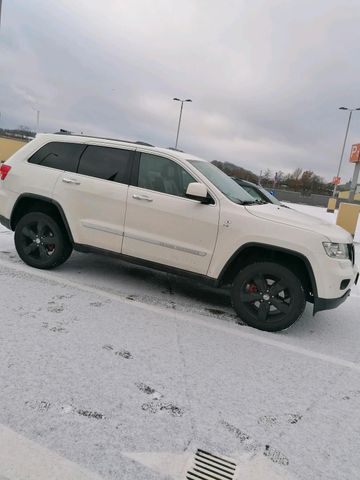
xmin=78 ymin=145 xmax=132 ymax=183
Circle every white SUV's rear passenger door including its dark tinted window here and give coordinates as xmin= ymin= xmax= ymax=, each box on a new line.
xmin=54 ymin=145 xmax=134 ymax=253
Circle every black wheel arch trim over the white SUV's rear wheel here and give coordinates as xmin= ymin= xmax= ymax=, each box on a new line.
xmin=9 ymin=193 xmax=74 ymax=244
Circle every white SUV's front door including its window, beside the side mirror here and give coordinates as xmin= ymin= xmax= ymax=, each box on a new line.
xmin=122 ymin=153 xmax=219 ymax=275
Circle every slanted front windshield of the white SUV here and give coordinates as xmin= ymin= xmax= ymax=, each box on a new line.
xmin=188 ymin=160 xmax=257 ymax=205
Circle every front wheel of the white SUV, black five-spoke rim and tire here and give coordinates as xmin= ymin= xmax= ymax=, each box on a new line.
xmin=231 ymin=262 xmax=306 ymax=332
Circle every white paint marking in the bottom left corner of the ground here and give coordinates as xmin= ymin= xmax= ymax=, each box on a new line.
xmin=0 ymin=424 xmax=102 ymax=480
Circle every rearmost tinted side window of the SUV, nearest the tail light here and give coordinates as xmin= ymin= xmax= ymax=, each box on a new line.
xmin=29 ymin=142 xmax=85 ymax=172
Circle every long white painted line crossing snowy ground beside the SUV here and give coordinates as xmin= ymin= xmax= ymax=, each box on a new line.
xmin=0 ymin=259 xmax=360 ymax=372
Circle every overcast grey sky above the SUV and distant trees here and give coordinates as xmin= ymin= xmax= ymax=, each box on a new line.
xmin=0 ymin=0 xmax=360 ymax=180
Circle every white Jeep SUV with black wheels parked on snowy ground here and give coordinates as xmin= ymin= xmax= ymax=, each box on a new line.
xmin=0 ymin=134 xmax=359 ymax=331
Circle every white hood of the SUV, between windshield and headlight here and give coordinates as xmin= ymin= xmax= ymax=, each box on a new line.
xmin=245 ymin=203 xmax=353 ymax=243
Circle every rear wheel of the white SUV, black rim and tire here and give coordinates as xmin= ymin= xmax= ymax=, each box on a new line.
xmin=15 ymin=212 xmax=72 ymax=269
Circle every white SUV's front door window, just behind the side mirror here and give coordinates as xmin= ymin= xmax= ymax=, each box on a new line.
xmin=138 ymin=153 xmax=196 ymax=197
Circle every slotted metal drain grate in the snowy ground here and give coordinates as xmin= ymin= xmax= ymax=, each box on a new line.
xmin=186 ymin=450 xmax=236 ymax=480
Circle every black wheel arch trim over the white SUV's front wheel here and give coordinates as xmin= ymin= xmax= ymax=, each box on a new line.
xmin=217 ymin=243 xmax=317 ymax=303
